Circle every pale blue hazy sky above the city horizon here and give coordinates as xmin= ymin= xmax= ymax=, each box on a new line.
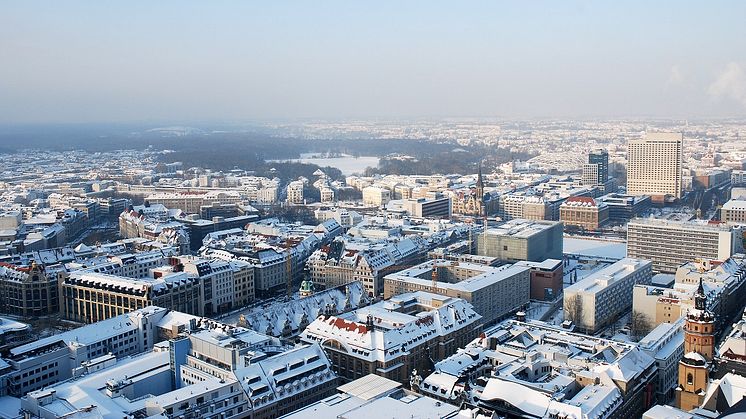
xmin=0 ymin=0 xmax=746 ymax=123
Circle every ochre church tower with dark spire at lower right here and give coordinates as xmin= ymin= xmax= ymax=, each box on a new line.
xmin=676 ymin=279 xmax=715 ymax=411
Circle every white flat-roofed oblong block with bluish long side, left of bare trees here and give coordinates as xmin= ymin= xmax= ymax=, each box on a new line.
xmin=563 ymin=258 xmax=653 ymax=334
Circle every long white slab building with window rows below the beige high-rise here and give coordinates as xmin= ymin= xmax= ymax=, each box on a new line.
xmin=627 ymin=218 xmax=743 ymax=273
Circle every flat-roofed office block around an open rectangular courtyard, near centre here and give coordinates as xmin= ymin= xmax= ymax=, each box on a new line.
xmin=383 ymin=259 xmax=530 ymax=324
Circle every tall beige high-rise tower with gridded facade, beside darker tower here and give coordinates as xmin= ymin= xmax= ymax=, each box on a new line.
xmin=627 ymin=132 xmax=684 ymax=198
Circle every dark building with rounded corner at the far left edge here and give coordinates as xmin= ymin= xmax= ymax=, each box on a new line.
xmin=0 ymin=262 xmax=60 ymax=317
